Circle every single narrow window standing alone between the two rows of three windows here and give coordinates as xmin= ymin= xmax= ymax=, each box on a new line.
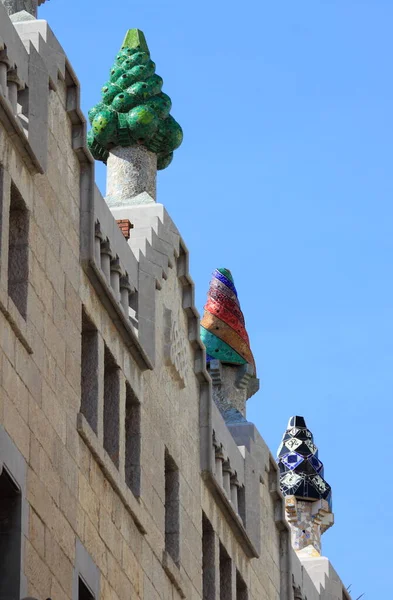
xmin=165 ymin=450 xmax=180 ymax=565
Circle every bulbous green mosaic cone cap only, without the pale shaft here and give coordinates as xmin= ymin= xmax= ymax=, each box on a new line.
xmin=88 ymin=29 xmax=183 ymax=169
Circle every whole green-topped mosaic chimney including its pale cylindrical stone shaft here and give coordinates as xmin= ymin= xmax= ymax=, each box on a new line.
xmin=88 ymin=29 xmax=183 ymax=208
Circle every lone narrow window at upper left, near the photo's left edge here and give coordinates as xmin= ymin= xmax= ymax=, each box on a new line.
xmin=8 ymin=183 xmax=29 ymax=319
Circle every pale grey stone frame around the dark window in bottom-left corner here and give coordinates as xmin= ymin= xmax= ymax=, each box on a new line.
xmin=0 ymin=425 xmax=29 ymax=598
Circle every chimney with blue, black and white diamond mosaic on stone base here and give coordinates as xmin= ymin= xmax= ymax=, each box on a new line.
xmin=277 ymin=416 xmax=334 ymax=556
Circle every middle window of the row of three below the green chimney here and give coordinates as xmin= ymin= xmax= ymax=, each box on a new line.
xmin=104 ymin=345 xmax=120 ymax=468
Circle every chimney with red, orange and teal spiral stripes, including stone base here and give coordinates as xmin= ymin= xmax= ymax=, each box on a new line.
xmin=201 ymin=268 xmax=259 ymax=422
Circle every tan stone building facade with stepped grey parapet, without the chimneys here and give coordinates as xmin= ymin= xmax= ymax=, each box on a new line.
xmin=0 ymin=0 xmax=349 ymax=600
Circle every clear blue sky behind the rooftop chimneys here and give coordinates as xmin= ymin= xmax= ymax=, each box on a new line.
xmin=40 ymin=0 xmax=393 ymax=600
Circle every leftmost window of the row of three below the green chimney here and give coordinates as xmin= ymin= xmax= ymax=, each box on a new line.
xmin=81 ymin=310 xmax=99 ymax=434
